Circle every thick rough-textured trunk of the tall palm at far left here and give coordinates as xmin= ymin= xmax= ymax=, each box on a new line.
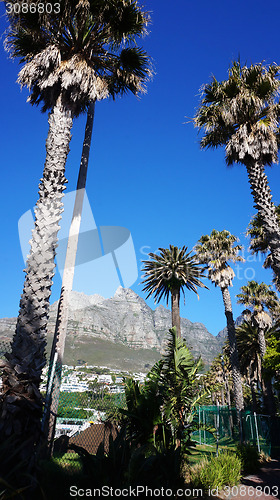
xmin=0 ymin=99 xmax=73 ymax=457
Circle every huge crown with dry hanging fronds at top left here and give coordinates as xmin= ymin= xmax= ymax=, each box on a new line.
xmin=6 ymin=0 xmax=151 ymax=114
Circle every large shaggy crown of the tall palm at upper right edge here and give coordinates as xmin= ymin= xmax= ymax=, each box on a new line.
xmin=194 ymin=61 xmax=280 ymax=165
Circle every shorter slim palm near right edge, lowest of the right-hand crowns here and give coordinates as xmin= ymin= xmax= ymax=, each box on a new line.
xmin=237 ymin=280 xmax=278 ymax=414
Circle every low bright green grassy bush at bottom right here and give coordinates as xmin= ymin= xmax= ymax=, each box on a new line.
xmin=190 ymin=452 xmax=241 ymax=491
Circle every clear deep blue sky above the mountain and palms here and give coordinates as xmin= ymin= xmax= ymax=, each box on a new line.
xmin=0 ymin=0 xmax=280 ymax=335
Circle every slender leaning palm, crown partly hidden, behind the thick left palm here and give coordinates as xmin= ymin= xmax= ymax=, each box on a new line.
xmin=42 ymin=6 xmax=151 ymax=449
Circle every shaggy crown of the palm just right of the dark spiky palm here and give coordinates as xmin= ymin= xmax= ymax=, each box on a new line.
xmin=195 ymin=229 xmax=244 ymax=287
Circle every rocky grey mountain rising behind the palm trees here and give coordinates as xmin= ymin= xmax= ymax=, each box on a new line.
xmin=0 ymin=287 xmax=221 ymax=371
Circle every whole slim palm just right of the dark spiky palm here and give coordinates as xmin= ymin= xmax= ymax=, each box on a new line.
xmin=195 ymin=229 xmax=244 ymax=410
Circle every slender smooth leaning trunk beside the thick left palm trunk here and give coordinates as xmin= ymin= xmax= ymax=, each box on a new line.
xmin=42 ymin=102 xmax=95 ymax=447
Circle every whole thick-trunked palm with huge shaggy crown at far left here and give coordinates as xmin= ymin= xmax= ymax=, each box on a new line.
xmin=0 ymin=0 xmax=149 ymax=454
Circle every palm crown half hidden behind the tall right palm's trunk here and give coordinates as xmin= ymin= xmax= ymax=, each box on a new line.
xmin=247 ymin=205 xmax=280 ymax=288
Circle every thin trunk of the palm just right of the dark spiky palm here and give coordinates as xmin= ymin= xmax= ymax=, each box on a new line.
xmin=221 ymin=287 xmax=244 ymax=410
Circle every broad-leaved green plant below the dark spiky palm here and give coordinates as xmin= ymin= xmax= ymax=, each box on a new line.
xmin=119 ymin=328 xmax=205 ymax=450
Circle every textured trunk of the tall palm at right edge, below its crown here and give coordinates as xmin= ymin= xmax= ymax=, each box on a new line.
xmin=246 ymin=162 xmax=280 ymax=290
